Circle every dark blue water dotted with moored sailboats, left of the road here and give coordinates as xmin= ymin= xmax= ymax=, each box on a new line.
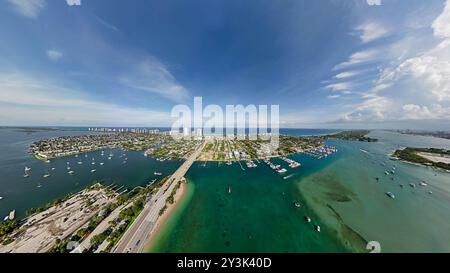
xmin=0 ymin=128 xmax=181 ymax=219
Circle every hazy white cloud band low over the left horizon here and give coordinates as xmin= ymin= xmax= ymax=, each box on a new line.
xmin=0 ymin=74 xmax=171 ymax=126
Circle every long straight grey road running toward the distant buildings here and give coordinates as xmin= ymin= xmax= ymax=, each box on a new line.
xmin=114 ymin=142 xmax=206 ymax=253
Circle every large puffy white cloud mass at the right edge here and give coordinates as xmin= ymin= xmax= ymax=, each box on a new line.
xmin=345 ymin=0 xmax=450 ymax=121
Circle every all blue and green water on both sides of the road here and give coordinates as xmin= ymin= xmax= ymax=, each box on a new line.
xmin=0 ymin=128 xmax=450 ymax=252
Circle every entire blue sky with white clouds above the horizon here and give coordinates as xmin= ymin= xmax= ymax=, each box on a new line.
xmin=0 ymin=0 xmax=450 ymax=129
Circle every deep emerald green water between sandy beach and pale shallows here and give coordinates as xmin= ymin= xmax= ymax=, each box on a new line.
xmin=149 ymin=155 xmax=349 ymax=253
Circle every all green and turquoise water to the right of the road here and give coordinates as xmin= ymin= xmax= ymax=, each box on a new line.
xmin=149 ymin=131 xmax=450 ymax=252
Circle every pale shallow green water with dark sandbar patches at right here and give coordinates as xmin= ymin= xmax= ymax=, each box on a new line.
xmin=299 ymin=131 xmax=450 ymax=252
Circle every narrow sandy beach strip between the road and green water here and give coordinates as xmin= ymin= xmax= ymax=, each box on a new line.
xmin=143 ymin=178 xmax=188 ymax=253
